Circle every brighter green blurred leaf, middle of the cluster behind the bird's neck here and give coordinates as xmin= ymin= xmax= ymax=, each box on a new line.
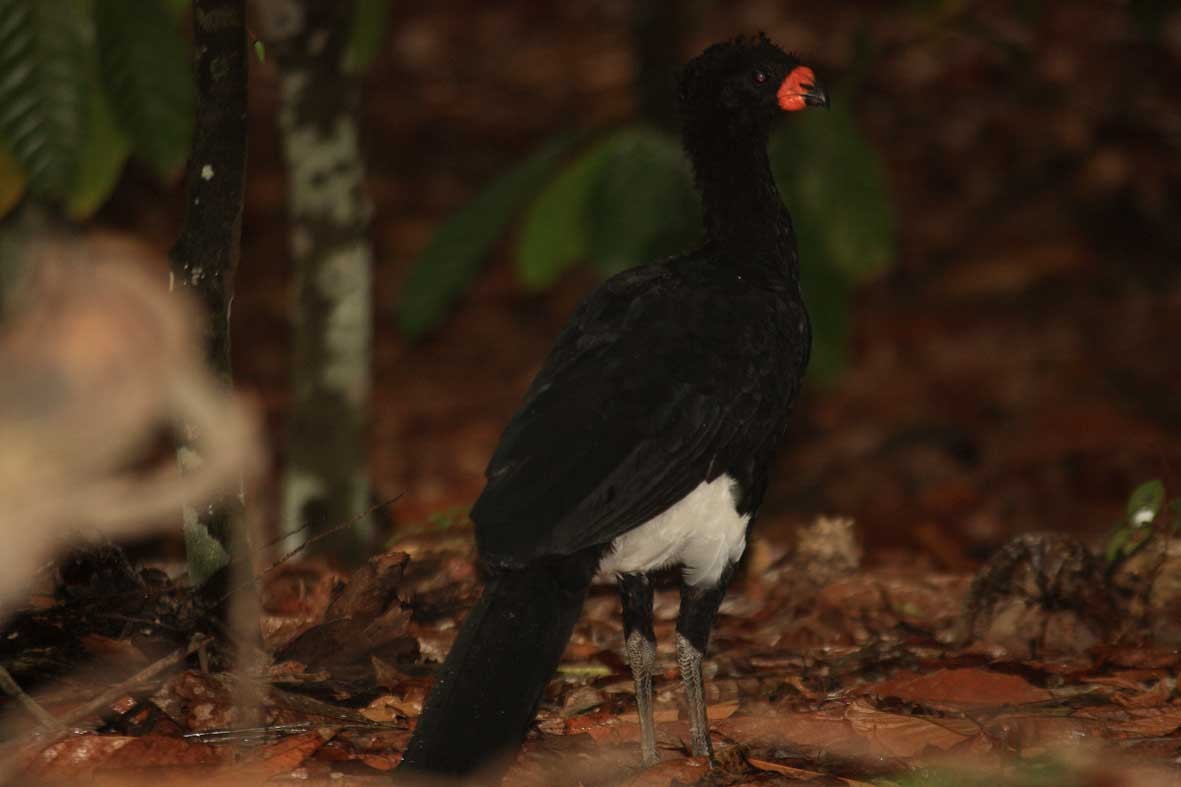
xmin=516 ymin=132 xmax=619 ymax=291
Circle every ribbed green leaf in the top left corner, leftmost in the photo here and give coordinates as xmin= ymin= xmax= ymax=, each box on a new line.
xmin=0 ymin=0 xmax=89 ymax=199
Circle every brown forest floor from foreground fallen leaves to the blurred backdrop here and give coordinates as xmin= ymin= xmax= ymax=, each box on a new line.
xmin=0 ymin=0 xmax=1181 ymax=787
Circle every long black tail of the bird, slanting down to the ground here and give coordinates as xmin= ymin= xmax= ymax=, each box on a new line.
xmin=398 ymin=549 xmax=599 ymax=780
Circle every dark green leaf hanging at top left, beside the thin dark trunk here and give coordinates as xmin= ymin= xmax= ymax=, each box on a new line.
xmin=94 ymin=0 xmax=196 ymax=181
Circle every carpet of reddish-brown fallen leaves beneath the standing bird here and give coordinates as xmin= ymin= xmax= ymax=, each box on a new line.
xmin=0 ymin=512 xmax=1181 ymax=785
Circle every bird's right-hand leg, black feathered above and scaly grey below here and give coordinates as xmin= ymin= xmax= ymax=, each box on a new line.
xmin=677 ymin=572 xmax=730 ymax=763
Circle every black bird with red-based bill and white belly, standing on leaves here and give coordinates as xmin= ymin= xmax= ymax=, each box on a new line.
xmin=402 ymin=35 xmax=828 ymax=775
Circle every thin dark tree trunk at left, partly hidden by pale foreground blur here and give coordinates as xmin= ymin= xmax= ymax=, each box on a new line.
xmin=170 ymin=0 xmax=247 ymax=585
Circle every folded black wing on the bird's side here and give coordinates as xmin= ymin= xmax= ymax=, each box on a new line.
xmin=471 ymin=261 xmax=798 ymax=564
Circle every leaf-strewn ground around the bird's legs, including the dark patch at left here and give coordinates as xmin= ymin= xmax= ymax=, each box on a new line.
xmin=0 ymin=519 xmax=1181 ymax=787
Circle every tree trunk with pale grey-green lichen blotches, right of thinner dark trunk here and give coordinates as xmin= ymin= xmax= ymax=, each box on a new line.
xmin=257 ymin=0 xmax=374 ymax=562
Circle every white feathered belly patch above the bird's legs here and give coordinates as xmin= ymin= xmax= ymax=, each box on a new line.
xmin=599 ymin=467 xmax=750 ymax=586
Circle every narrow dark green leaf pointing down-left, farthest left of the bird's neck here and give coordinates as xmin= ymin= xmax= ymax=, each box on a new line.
xmin=398 ymin=135 xmax=579 ymax=338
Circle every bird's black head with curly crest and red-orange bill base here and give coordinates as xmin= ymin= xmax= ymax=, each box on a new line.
xmin=679 ymin=33 xmax=828 ymax=135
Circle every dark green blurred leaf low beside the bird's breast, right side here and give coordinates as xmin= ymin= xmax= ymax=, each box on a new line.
xmin=800 ymin=254 xmax=853 ymax=384
